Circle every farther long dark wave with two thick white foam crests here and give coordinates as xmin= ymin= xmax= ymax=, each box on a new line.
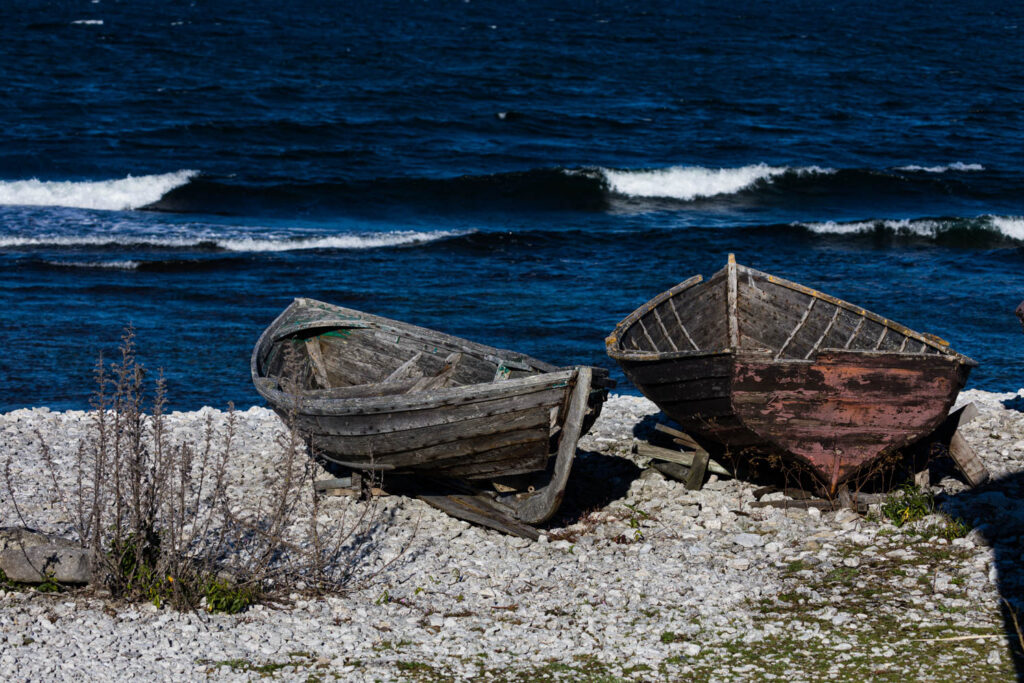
xmin=6 ymin=163 xmax=989 ymax=217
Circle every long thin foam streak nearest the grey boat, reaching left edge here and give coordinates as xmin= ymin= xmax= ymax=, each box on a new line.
xmin=0 ymin=230 xmax=464 ymax=252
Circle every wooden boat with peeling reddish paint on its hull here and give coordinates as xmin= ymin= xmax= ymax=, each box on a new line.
xmin=606 ymin=255 xmax=977 ymax=493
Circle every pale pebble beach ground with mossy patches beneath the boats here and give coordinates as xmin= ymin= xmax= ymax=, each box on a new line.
xmin=0 ymin=390 xmax=1024 ymax=681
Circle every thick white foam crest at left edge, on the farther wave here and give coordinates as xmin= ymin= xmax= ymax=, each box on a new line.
xmin=0 ymin=170 xmax=197 ymax=211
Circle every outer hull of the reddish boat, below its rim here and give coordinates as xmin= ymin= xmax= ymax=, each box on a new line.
xmin=623 ymin=352 xmax=970 ymax=492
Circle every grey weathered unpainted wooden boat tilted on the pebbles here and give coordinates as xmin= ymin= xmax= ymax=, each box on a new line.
xmin=251 ymin=298 xmax=613 ymax=524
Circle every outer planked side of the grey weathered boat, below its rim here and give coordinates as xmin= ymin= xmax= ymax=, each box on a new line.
xmin=264 ymin=371 xmax=578 ymax=479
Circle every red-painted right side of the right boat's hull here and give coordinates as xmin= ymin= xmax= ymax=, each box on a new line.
xmin=732 ymin=352 xmax=966 ymax=490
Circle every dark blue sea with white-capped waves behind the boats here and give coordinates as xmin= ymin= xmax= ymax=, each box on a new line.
xmin=0 ymin=0 xmax=1024 ymax=410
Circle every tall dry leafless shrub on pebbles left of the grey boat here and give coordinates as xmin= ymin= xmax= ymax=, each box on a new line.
xmin=2 ymin=328 xmax=395 ymax=613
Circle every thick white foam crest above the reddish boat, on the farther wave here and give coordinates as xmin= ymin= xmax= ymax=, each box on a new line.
xmin=600 ymin=164 xmax=835 ymax=202
